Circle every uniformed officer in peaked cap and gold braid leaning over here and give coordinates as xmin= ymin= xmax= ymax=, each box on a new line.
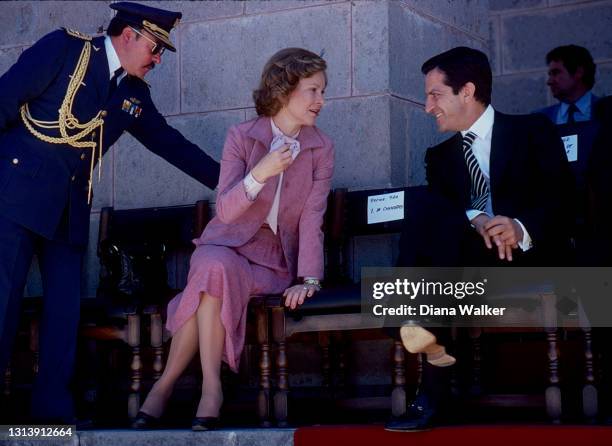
xmin=0 ymin=2 xmax=219 ymax=422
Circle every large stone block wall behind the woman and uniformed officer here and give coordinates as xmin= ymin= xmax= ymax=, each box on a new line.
xmin=0 ymin=0 xmax=488 ymax=296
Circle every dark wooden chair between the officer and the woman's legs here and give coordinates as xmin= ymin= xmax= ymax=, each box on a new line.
xmin=80 ymin=200 xmax=209 ymax=418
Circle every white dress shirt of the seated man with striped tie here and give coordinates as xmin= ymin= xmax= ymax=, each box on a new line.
xmin=461 ymin=105 xmax=531 ymax=251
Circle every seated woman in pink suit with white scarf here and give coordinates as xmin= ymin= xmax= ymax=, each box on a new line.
xmin=133 ymin=48 xmax=334 ymax=430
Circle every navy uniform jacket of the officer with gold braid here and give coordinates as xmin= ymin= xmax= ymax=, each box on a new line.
xmin=0 ymin=30 xmax=219 ymax=246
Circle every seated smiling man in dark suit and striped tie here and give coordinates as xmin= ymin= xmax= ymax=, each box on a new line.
xmin=387 ymin=47 xmax=571 ymax=430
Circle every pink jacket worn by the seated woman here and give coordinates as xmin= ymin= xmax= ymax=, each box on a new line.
xmin=195 ymin=117 xmax=334 ymax=278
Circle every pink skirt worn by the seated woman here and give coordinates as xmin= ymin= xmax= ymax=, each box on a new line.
xmin=166 ymin=227 xmax=292 ymax=372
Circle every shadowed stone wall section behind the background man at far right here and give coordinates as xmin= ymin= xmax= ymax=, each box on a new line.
xmin=489 ymin=0 xmax=612 ymax=113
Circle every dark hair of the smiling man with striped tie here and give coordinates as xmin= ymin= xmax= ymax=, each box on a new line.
xmin=421 ymin=46 xmax=493 ymax=105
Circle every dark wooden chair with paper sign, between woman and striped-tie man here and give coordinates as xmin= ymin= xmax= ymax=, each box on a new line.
xmin=261 ymin=188 xmax=418 ymax=426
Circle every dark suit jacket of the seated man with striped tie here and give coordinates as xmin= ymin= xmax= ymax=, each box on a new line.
xmin=425 ymin=111 xmax=573 ymax=260
